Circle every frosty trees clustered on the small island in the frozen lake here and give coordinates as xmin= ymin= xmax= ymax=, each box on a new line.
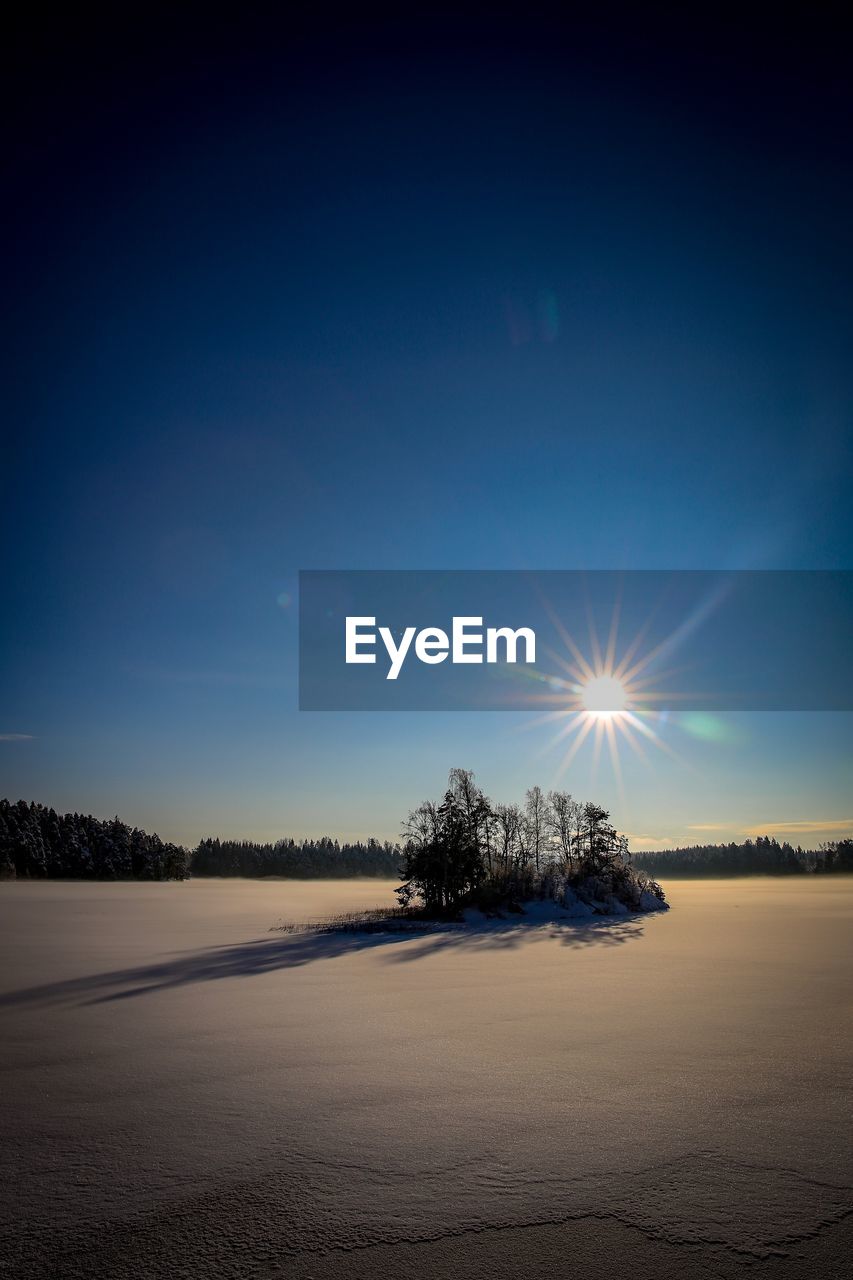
xmin=397 ymin=769 xmax=662 ymax=915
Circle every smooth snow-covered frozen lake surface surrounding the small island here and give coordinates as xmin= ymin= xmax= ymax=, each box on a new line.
xmin=0 ymin=879 xmax=853 ymax=1280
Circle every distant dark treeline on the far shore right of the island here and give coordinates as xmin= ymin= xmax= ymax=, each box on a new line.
xmin=634 ymin=836 xmax=853 ymax=877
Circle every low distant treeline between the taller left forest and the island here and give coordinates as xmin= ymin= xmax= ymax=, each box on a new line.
xmin=190 ymin=836 xmax=401 ymax=879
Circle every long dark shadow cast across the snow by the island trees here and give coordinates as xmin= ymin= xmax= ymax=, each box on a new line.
xmin=0 ymin=916 xmax=644 ymax=1007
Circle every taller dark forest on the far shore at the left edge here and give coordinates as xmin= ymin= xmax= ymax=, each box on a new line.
xmin=0 ymin=800 xmax=190 ymax=879
